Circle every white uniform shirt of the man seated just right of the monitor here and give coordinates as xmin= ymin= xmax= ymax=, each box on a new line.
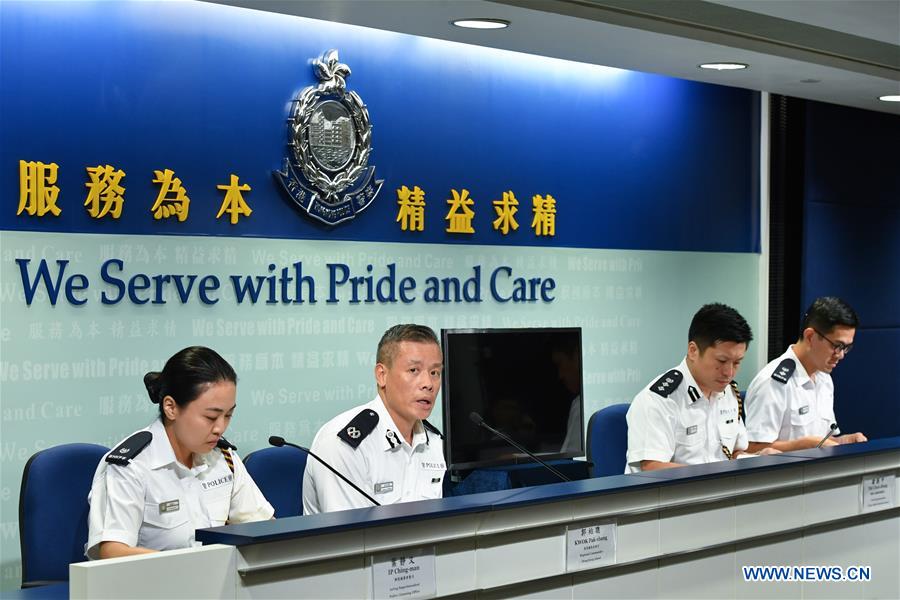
xmin=625 ymin=360 xmax=747 ymax=473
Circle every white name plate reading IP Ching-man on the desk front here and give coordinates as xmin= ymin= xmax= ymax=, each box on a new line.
xmin=372 ymin=546 xmax=437 ymax=600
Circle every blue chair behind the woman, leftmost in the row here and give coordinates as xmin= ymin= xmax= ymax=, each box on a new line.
xmin=19 ymin=444 xmax=109 ymax=588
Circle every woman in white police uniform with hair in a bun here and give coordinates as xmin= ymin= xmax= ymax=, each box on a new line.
xmin=85 ymin=347 xmax=275 ymax=559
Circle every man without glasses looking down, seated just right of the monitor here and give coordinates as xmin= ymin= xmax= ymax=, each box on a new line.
xmin=625 ymin=304 xmax=770 ymax=473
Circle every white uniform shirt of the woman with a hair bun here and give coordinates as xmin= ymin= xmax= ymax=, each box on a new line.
xmin=85 ymin=419 xmax=275 ymax=559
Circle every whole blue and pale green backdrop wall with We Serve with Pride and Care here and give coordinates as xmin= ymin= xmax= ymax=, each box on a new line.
xmin=0 ymin=1 xmax=760 ymax=589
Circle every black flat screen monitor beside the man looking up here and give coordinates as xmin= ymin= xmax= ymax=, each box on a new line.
xmin=441 ymin=328 xmax=584 ymax=471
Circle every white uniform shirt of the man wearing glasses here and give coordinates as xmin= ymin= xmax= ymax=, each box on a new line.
xmin=745 ymin=347 xmax=836 ymax=444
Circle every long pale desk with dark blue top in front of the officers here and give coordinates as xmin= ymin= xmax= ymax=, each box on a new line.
xmin=71 ymin=438 xmax=900 ymax=599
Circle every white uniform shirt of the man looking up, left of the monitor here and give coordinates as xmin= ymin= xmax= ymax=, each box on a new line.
xmin=303 ymin=396 xmax=447 ymax=515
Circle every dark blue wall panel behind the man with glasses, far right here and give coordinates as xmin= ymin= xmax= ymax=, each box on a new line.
xmin=797 ymin=102 xmax=900 ymax=438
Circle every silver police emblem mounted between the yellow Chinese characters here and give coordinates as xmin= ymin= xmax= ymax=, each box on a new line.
xmin=274 ymin=50 xmax=384 ymax=225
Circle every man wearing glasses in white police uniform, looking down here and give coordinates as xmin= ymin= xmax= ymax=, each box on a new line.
xmin=744 ymin=296 xmax=867 ymax=452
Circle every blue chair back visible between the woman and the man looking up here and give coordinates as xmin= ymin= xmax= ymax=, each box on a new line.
xmin=244 ymin=446 xmax=306 ymax=517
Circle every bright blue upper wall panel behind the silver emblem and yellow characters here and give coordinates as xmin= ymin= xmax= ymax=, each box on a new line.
xmin=0 ymin=2 xmax=759 ymax=252
